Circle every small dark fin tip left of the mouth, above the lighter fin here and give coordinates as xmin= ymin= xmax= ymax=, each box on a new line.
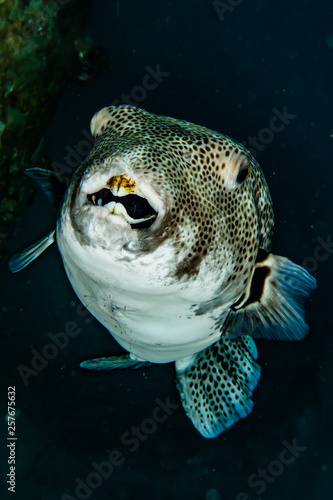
xmin=24 ymin=167 xmax=67 ymax=208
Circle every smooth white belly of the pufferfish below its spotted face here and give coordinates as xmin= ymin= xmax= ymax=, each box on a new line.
xmin=57 ymin=221 xmax=226 ymax=363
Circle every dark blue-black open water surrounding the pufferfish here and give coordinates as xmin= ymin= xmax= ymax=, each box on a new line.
xmin=1 ymin=0 xmax=333 ymax=500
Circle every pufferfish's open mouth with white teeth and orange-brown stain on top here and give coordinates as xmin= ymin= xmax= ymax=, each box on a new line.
xmin=87 ymin=174 xmax=158 ymax=229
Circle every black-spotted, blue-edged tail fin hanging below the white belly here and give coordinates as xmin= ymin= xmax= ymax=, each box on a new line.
xmin=176 ymin=337 xmax=260 ymax=438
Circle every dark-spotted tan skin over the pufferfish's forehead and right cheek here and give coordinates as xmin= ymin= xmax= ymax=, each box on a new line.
xmin=63 ymin=105 xmax=274 ymax=295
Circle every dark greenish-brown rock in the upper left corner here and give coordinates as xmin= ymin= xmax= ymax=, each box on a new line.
xmin=0 ymin=0 xmax=106 ymax=258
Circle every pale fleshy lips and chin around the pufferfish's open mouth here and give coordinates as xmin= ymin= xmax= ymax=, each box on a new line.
xmin=73 ymin=168 xmax=167 ymax=252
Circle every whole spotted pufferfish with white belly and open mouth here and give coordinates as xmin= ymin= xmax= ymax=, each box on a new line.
xmin=10 ymin=105 xmax=316 ymax=438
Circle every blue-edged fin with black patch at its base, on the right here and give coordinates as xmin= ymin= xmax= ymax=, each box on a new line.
xmin=224 ymin=253 xmax=317 ymax=340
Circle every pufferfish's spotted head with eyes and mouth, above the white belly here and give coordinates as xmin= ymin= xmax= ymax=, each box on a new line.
xmin=58 ymin=105 xmax=273 ymax=300
